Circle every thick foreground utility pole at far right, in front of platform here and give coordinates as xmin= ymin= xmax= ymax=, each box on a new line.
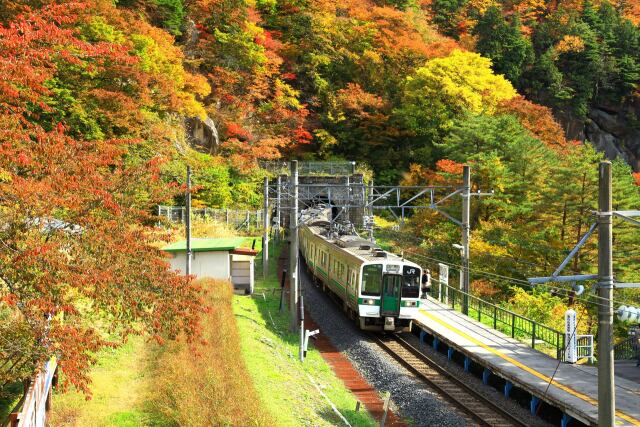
xmin=598 ymin=161 xmax=616 ymax=427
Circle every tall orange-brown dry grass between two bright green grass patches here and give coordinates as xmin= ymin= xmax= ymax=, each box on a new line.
xmin=151 ymin=279 xmax=273 ymax=426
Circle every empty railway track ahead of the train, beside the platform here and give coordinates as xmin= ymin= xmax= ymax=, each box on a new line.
xmin=372 ymin=334 xmax=527 ymax=427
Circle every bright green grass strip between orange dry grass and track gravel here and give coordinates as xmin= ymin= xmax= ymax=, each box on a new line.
xmin=239 ymin=244 xmax=377 ymax=426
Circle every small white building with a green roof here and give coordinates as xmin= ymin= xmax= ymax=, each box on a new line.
xmin=162 ymin=237 xmax=257 ymax=293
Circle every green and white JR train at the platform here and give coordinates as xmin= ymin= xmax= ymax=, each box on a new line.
xmin=299 ymin=212 xmax=422 ymax=332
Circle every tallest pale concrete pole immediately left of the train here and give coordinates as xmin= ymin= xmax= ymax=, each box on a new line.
xmin=289 ymin=160 xmax=298 ymax=332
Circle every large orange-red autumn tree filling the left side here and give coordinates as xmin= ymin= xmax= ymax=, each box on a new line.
xmin=0 ymin=2 xmax=201 ymax=390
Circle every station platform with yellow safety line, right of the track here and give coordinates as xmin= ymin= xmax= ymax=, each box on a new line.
xmin=414 ymin=297 xmax=640 ymax=426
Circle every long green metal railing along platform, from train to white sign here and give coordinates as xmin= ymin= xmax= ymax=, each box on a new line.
xmin=431 ymin=281 xmax=565 ymax=360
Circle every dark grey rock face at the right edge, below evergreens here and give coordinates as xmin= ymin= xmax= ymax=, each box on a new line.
xmin=557 ymin=105 xmax=640 ymax=172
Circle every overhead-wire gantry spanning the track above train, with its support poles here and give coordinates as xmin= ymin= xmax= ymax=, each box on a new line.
xmin=263 ymin=161 xmax=493 ymax=329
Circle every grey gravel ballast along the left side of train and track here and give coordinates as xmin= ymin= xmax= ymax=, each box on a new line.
xmin=301 ymin=269 xmax=475 ymax=426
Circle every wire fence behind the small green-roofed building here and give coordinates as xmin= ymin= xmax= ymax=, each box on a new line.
xmin=157 ymin=206 xmax=264 ymax=231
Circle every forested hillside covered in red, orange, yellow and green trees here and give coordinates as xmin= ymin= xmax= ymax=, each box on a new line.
xmin=0 ymin=0 xmax=640 ymax=412
